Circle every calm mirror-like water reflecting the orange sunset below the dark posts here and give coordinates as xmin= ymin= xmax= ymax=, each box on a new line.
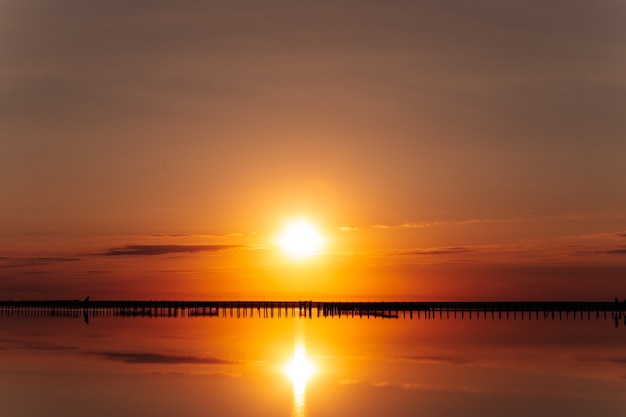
xmin=0 ymin=310 xmax=626 ymax=417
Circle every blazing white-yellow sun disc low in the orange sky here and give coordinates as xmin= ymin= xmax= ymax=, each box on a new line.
xmin=278 ymin=220 xmax=325 ymax=259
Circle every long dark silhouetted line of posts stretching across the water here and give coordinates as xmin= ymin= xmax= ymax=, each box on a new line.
xmin=0 ymin=299 xmax=626 ymax=325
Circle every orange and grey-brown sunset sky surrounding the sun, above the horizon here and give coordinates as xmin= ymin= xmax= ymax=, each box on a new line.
xmin=0 ymin=0 xmax=626 ymax=300
